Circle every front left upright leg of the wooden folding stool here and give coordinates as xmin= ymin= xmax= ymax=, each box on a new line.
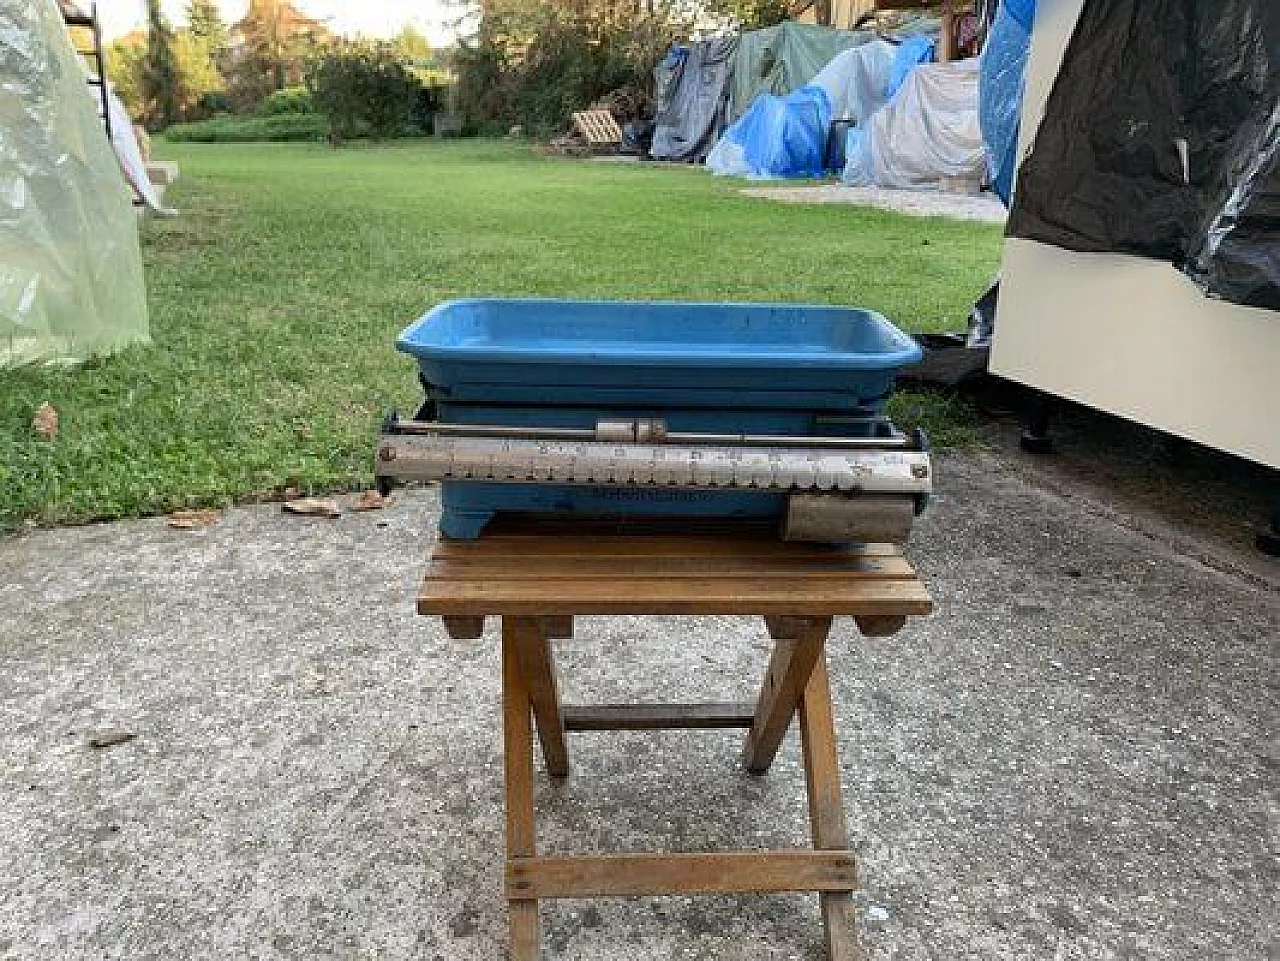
xmin=502 ymin=617 xmax=538 ymax=961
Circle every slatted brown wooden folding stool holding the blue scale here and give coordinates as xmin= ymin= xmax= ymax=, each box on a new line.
xmin=417 ymin=532 xmax=932 ymax=961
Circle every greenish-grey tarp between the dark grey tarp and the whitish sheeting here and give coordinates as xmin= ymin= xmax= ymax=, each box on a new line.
xmin=728 ymin=20 xmax=876 ymax=120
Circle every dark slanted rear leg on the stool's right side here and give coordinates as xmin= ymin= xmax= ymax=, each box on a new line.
xmin=744 ymin=617 xmax=831 ymax=774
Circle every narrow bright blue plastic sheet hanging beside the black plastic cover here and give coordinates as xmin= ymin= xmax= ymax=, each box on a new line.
xmin=978 ymin=0 xmax=1036 ymax=207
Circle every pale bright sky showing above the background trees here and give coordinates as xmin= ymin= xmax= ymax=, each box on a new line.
xmin=98 ymin=0 xmax=458 ymax=46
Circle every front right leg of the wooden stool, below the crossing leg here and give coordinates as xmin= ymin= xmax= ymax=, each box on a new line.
xmin=800 ymin=653 xmax=865 ymax=961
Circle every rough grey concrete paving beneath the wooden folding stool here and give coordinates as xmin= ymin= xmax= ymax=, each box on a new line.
xmin=0 ymin=452 xmax=1280 ymax=961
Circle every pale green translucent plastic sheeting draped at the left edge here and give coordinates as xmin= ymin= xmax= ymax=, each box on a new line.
xmin=0 ymin=0 xmax=148 ymax=369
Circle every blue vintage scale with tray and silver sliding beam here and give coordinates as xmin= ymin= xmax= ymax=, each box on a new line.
xmin=378 ymin=299 xmax=932 ymax=543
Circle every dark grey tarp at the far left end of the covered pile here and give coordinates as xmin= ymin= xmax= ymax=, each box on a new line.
xmin=649 ymin=37 xmax=737 ymax=163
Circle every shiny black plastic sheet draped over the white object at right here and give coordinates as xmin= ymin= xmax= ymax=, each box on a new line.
xmin=1007 ymin=0 xmax=1280 ymax=308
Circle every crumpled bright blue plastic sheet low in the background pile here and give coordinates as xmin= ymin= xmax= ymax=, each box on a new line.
xmin=707 ymin=84 xmax=832 ymax=180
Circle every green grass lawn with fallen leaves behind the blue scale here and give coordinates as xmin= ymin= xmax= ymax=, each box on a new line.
xmin=0 ymin=141 xmax=1000 ymax=527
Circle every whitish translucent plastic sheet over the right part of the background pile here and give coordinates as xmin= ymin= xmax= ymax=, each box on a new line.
xmin=842 ymin=60 xmax=987 ymax=187
